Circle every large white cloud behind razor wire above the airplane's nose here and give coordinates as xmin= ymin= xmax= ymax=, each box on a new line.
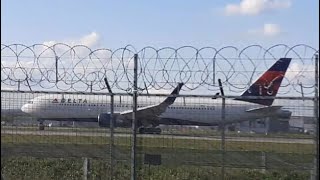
xmin=1 ymin=32 xmax=103 ymax=88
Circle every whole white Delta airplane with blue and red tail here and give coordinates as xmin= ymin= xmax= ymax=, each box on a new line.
xmin=21 ymin=58 xmax=291 ymax=134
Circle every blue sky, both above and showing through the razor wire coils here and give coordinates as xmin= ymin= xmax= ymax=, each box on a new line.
xmin=1 ymin=0 xmax=319 ymax=97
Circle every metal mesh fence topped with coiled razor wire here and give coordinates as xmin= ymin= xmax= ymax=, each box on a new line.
xmin=1 ymin=43 xmax=319 ymax=179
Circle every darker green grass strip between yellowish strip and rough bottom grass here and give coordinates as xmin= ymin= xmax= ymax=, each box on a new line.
xmin=1 ymin=143 xmax=314 ymax=169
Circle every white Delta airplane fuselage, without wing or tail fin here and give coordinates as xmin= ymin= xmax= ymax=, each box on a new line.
xmin=21 ymin=95 xmax=282 ymax=125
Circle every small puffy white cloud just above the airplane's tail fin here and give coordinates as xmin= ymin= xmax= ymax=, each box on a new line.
xmin=248 ymin=23 xmax=282 ymax=37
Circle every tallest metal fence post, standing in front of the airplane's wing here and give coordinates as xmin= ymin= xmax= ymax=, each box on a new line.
xmin=131 ymin=54 xmax=138 ymax=180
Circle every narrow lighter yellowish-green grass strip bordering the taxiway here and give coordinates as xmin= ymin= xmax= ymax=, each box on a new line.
xmin=1 ymin=134 xmax=315 ymax=154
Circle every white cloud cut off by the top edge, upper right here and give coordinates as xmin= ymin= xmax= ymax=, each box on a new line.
xmin=224 ymin=0 xmax=291 ymax=16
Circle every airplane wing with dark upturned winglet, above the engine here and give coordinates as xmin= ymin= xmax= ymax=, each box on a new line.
xmin=120 ymin=83 xmax=183 ymax=126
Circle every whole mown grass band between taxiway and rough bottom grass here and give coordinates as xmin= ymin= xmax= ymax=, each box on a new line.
xmin=1 ymin=135 xmax=314 ymax=173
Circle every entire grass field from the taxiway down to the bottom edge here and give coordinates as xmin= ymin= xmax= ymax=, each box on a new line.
xmin=1 ymin=128 xmax=315 ymax=180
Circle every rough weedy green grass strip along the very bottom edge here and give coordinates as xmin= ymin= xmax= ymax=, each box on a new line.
xmin=1 ymin=157 xmax=310 ymax=180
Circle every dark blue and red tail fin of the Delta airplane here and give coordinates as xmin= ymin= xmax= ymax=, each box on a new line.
xmin=236 ymin=58 xmax=291 ymax=106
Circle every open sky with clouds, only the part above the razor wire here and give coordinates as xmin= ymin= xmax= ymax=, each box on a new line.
xmin=1 ymin=0 xmax=319 ymax=49
